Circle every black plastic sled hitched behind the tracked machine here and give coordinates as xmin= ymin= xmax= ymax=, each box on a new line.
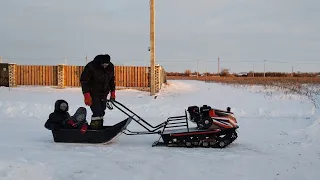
xmin=52 ymin=118 xmax=131 ymax=143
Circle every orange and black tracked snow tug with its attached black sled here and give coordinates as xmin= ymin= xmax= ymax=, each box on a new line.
xmin=48 ymin=101 xmax=239 ymax=148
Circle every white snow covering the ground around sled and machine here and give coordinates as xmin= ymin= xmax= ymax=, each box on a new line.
xmin=0 ymin=81 xmax=320 ymax=180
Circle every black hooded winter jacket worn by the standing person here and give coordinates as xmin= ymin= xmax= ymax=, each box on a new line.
xmin=80 ymin=58 xmax=115 ymax=97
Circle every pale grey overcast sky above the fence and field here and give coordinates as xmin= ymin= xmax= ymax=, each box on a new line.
xmin=0 ymin=0 xmax=320 ymax=72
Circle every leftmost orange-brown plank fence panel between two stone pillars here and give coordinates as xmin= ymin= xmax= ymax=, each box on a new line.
xmin=16 ymin=65 xmax=58 ymax=86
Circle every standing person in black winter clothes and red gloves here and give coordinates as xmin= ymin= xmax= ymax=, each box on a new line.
xmin=80 ymin=54 xmax=115 ymax=129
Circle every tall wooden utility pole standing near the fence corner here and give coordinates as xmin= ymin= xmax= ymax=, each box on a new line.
xmin=150 ymin=0 xmax=156 ymax=96
